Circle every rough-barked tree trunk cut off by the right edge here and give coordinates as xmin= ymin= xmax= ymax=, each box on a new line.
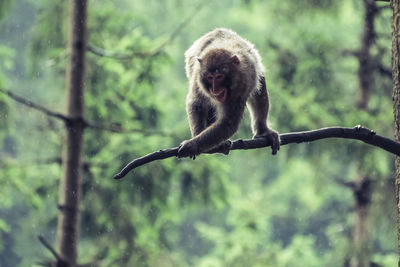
xmin=391 ymin=0 xmax=400 ymax=267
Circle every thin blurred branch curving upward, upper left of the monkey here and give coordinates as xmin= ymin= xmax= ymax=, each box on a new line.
xmin=87 ymin=1 xmax=205 ymax=60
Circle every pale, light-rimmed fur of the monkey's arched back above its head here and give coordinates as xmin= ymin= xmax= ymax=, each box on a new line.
xmin=185 ymin=28 xmax=264 ymax=79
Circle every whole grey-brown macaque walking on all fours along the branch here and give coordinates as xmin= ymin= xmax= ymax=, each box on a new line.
xmin=178 ymin=29 xmax=280 ymax=159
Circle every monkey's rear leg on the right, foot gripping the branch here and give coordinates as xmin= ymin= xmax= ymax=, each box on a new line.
xmin=247 ymin=76 xmax=280 ymax=154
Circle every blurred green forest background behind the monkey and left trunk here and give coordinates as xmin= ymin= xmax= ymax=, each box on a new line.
xmin=0 ymin=0 xmax=397 ymax=267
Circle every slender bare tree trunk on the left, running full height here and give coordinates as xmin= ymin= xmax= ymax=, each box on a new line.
xmin=57 ymin=0 xmax=87 ymax=266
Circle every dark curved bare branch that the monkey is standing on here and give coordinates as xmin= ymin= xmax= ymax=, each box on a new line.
xmin=114 ymin=125 xmax=400 ymax=179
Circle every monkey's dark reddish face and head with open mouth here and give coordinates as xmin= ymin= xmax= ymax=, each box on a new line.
xmin=198 ymin=50 xmax=239 ymax=103
